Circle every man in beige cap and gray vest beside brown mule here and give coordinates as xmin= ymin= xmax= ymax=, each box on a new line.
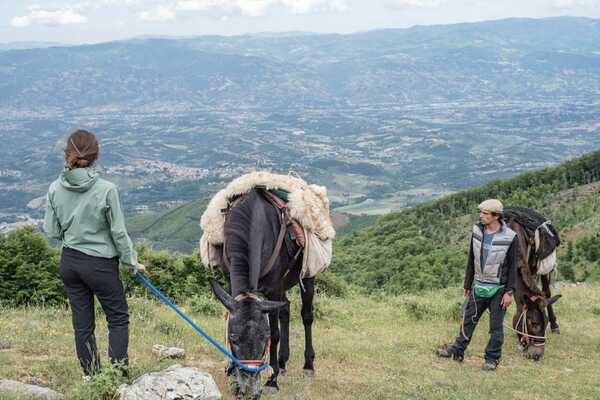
xmin=436 ymin=199 xmax=517 ymax=371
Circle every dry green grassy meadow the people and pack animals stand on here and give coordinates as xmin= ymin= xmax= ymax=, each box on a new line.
xmin=0 ymin=286 xmax=600 ymax=400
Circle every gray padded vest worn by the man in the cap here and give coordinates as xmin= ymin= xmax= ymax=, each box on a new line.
xmin=473 ymin=222 xmax=517 ymax=284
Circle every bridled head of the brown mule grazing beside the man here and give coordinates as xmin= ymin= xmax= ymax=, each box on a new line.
xmin=514 ymin=295 xmax=561 ymax=361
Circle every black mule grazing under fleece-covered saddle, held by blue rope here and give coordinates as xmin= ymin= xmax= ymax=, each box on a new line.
xmin=211 ymin=188 xmax=315 ymax=399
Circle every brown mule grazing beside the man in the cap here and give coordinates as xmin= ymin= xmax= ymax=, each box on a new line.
xmin=504 ymin=208 xmax=561 ymax=361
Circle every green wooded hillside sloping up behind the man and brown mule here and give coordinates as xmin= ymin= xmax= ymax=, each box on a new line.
xmin=331 ymin=152 xmax=600 ymax=293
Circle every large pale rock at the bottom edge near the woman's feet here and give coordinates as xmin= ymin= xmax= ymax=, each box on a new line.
xmin=117 ymin=365 xmax=221 ymax=400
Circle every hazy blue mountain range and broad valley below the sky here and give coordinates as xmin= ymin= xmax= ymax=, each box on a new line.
xmin=0 ymin=17 xmax=600 ymax=222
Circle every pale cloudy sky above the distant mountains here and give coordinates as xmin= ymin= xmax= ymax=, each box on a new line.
xmin=0 ymin=0 xmax=600 ymax=44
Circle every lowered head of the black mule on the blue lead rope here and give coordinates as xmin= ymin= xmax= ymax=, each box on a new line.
xmin=210 ymin=279 xmax=285 ymax=398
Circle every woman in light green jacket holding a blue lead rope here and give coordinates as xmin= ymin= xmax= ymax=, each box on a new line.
xmin=44 ymin=130 xmax=146 ymax=377
